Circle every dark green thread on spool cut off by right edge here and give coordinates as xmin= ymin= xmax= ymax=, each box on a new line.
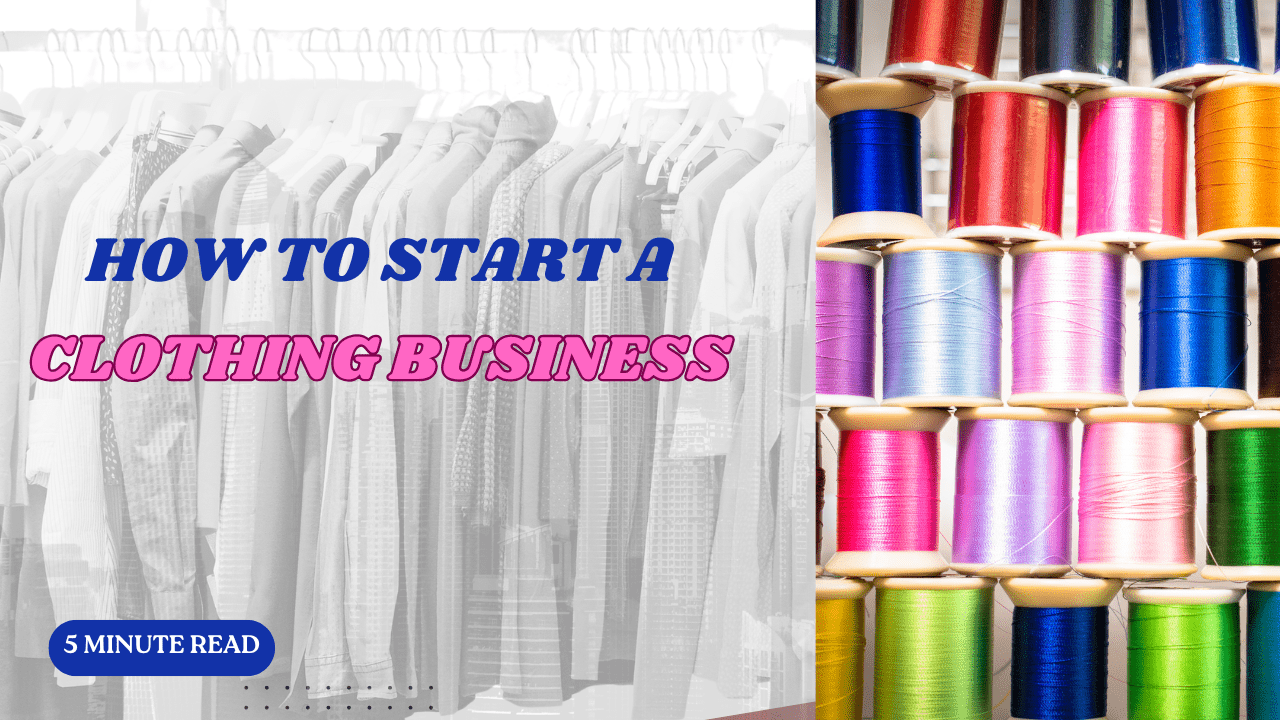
xmin=1204 ymin=428 xmax=1280 ymax=566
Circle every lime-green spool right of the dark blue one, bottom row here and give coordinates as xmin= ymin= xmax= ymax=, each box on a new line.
xmin=1124 ymin=587 xmax=1244 ymax=720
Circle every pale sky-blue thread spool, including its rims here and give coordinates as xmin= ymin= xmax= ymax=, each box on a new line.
xmin=881 ymin=238 xmax=1004 ymax=399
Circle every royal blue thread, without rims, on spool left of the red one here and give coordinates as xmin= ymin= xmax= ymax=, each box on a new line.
xmin=831 ymin=110 xmax=924 ymax=215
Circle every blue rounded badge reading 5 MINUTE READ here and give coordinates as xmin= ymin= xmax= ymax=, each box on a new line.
xmin=49 ymin=620 xmax=275 ymax=678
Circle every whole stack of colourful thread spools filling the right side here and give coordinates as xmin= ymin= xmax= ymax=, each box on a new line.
xmin=817 ymin=0 xmax=1280 ymax=720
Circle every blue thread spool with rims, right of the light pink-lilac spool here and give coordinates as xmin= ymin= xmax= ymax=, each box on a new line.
xmin=1133 ymin=240 xmax=1253 ymax=410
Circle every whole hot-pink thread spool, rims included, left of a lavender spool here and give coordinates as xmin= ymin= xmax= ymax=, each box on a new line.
xmin=827 ymin=407 xmax=951 ymax=578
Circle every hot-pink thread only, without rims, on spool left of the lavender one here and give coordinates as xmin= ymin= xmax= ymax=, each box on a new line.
xmin=836 ymin=430 xmax=938 ymax=552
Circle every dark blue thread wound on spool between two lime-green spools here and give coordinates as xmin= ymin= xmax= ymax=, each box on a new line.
xmin=1010 ymin=606 xmax=1108 ymax=720
